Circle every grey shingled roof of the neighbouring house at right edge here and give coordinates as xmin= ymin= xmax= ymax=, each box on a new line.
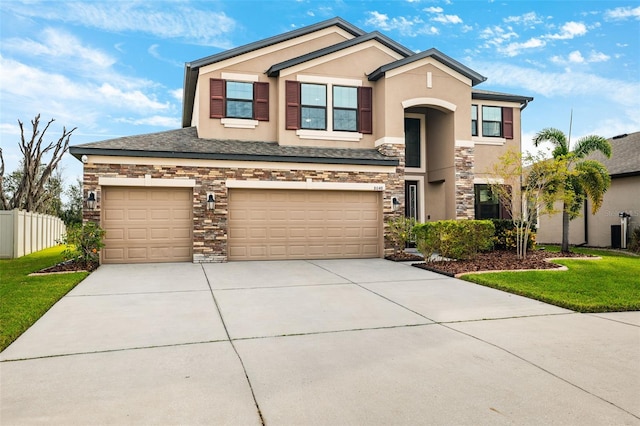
xmin=589 ymin=132 xmax=640 ymax=178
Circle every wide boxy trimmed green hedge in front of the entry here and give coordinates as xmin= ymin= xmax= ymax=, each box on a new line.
xmin=413 ymin=220 xmax=495 ymax=260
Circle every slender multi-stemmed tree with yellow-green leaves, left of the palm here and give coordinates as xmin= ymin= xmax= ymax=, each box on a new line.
xmin=489 ymin=150 xmax=567 ymax=259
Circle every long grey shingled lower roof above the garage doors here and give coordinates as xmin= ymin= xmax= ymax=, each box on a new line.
xmin=69 ymin=127 xmax=398 ymax=166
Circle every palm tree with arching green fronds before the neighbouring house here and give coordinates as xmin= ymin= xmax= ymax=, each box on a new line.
xmin=533 ymin=128 xmax=611 ymax=253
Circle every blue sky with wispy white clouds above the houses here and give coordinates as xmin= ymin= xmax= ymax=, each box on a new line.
xmin=0 ymin=0 xmax=640 ymax=182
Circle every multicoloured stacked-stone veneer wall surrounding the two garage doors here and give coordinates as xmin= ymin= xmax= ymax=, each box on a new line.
xmin=83 ymin=153 xmax=404 ymax=262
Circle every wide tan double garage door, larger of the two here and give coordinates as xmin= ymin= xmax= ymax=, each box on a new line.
xmin=228 ymin=188 xmax=382 ymax=260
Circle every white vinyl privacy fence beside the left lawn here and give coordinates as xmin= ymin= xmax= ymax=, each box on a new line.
xmin=0 ymin=209 xmax=66 ymax=259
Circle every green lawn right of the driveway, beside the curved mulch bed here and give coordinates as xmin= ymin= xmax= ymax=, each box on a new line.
xmin=462 ymin=247 xmax=640 ymax=312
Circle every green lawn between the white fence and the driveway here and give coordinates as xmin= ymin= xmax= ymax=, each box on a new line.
xmin=0 ymin=246 xmax=89 ymax=351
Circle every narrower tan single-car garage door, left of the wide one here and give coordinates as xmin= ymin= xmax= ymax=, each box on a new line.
xmin=102 ymin=187 xmax=193 ymax=263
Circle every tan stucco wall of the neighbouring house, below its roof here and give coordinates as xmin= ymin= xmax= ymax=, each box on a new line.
xmin=537 ymin=176 xmax=640 ymax=247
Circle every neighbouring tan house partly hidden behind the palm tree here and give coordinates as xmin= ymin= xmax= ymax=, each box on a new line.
xmin=537 ymin=132 xmax=640 ymax=247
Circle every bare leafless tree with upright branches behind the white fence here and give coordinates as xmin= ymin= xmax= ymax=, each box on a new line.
xmin=0 ymin=114 xmax=76 ymax=213
